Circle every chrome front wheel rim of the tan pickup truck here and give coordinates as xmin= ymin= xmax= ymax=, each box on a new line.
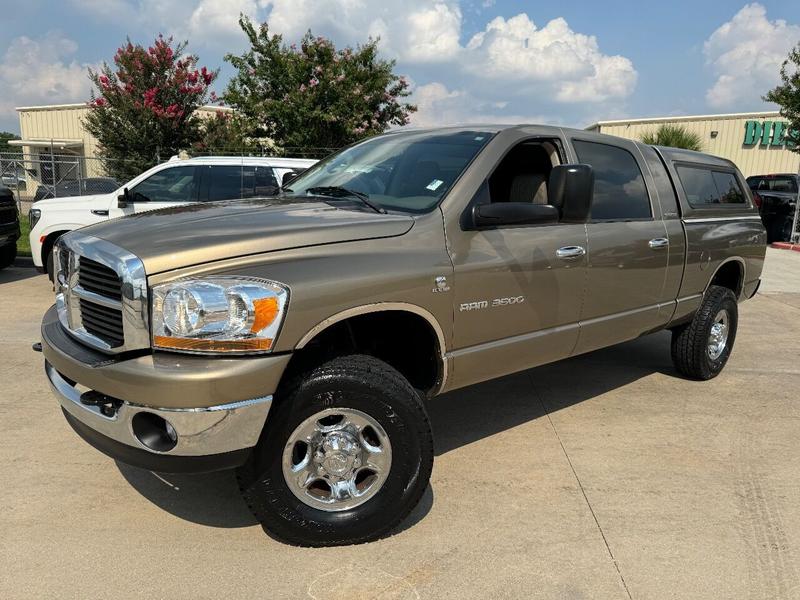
xmin=282 ymin=408 xmax=392 ymax=511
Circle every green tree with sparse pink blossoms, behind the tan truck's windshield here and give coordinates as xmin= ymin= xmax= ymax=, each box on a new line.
xmin=223 ymin=16 xmax=416 ymax=155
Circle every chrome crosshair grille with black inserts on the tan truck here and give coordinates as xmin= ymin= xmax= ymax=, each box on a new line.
xmin=54 ymin=232 xmax=150 ymax=354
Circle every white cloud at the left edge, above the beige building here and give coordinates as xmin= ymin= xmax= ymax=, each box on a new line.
xmin=0 ymin=32 xmax=92 ymax=120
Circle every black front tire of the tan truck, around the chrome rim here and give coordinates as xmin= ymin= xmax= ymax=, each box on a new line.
xmin=237 ymin=355 xmax=433 ymax=546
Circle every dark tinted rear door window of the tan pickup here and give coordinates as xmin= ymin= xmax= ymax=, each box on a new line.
xmin=573 ymin=141 xmax=651 ymax=221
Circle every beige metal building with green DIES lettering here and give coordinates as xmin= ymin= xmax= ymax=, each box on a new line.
xmin=586 ymin=112 xmax=800 ymax=177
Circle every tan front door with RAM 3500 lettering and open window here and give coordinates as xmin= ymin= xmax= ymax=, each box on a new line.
xmin=448 ymin=142 xmax=587 ymax=387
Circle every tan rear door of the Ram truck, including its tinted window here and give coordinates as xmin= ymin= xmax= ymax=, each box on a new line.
xmin=571 ymin=134 xmax=674 ymax=353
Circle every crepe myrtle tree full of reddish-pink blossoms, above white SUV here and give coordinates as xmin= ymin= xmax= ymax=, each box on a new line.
xmin=85 ymin=35 xmax=218 ymax=181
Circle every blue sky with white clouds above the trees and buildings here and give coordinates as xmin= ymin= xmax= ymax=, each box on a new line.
xmin=0 ymin=0 xmax=800 ymax=131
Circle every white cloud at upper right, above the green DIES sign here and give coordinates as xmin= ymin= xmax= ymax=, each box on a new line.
xmin=703 ymin=4 xmax=800 ymax=110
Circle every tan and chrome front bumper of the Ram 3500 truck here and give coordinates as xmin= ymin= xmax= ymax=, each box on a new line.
xmin=42 ymin=308 xmax=289 ymax=472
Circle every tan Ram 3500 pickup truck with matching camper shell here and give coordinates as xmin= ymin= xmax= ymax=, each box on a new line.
xmin=41 ymin=126 xmax=765 ymax=546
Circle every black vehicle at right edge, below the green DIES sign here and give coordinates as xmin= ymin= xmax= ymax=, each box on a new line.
xmin=747 ymin=173 xmax=800 ymax=242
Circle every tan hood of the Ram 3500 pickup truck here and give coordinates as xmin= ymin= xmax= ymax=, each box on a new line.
xmin=80 ymin=198 xmax=414 ymax=275
